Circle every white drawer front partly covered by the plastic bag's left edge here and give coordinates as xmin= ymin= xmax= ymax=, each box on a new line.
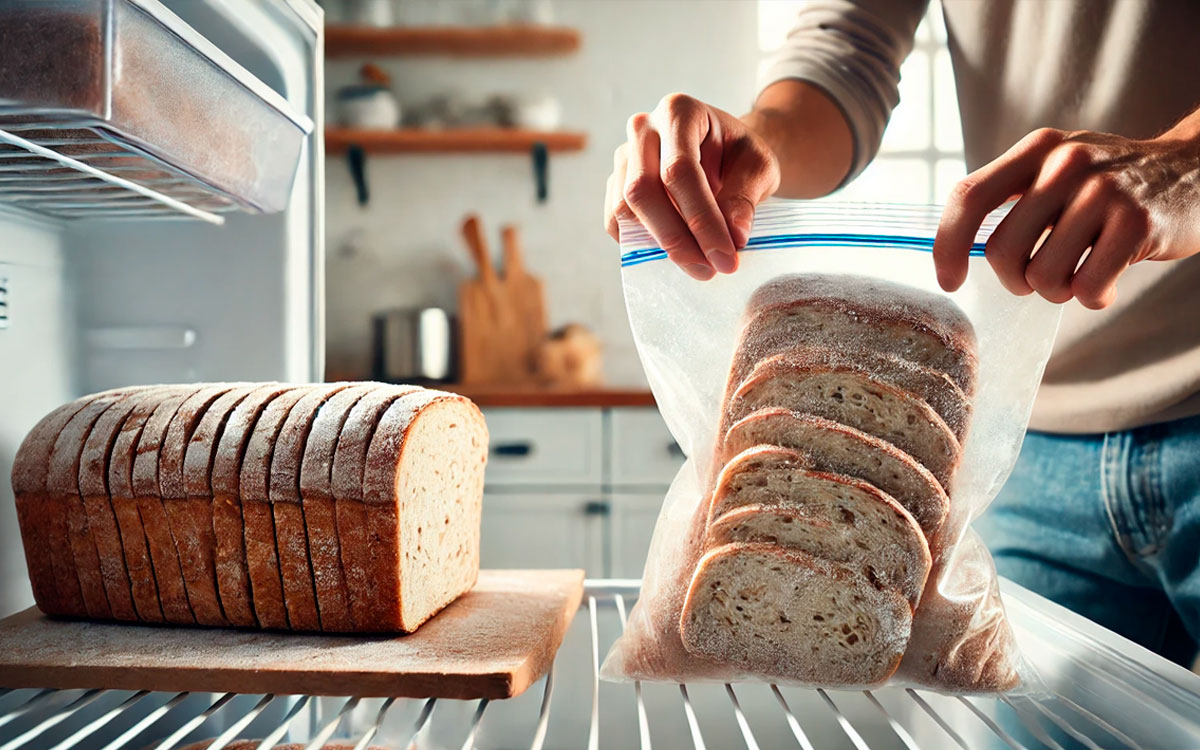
xmin=610 ymin=408 xmax=684 ymax=486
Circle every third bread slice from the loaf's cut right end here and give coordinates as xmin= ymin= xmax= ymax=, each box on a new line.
xmin=300 ymin=383 xmax=378 ymax=632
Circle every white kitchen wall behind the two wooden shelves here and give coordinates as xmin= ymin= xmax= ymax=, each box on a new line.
xmin=326 ymin=0 xmax=758 ymax=385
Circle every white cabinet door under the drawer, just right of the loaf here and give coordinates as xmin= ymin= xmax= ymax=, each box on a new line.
xmin=480 ymin=492 xmax=608 ymax=577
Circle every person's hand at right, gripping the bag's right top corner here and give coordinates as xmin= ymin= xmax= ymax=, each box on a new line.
xmin=934 ymin=124 xmax=1200 ymax=310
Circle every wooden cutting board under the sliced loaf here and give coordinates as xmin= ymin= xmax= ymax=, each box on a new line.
xmin=0 ymin=570 xmax=583 ymax=700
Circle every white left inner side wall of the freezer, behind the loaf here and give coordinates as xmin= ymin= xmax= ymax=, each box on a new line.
xmin=0 ymin=215 xmax=78 ymax=617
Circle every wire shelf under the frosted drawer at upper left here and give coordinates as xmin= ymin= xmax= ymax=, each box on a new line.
xmin=0 ymin=120 xmax=241 ymax=224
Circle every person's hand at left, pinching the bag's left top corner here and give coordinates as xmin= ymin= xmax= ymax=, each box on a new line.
xmin=605 ymin=94 xmax=779 ymax=281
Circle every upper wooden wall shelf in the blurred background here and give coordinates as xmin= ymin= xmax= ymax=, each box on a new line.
xmin=325 ymin=25 xmax=580 ymax=58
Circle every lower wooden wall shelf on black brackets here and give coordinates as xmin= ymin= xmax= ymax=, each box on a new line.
xmin=325 ymin=127 xmax=588 ymax=154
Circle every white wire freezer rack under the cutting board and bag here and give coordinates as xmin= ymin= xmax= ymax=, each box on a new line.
xmin=0 ymin=581 xmax=1200 ymax=750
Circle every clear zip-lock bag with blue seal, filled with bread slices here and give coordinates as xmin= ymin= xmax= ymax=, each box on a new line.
xmin=601 ymin=202 xmax=1060 ymax=692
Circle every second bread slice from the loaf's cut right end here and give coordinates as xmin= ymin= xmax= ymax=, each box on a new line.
xmin=330 ymin=385 xmax=420 ymax=632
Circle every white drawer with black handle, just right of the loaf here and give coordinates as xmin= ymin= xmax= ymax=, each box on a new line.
xmin=484 ymin=408 xmax=605 ymax=486
